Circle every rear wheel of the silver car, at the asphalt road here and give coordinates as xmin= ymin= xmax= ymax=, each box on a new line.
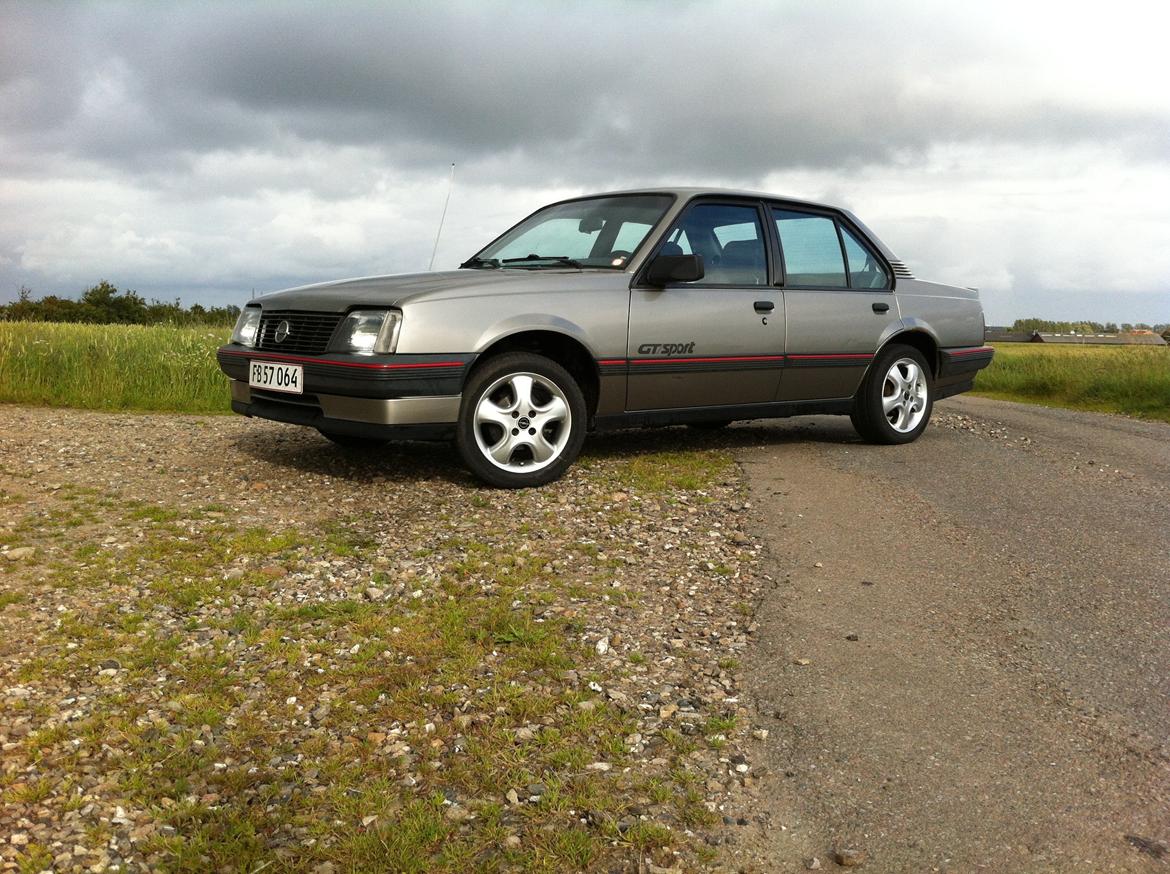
xmin=849 ymin=344 xmax=935 ymax=443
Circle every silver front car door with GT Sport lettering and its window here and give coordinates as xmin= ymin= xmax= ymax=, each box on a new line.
xmin=626 ymin=200 xmax=784 ymax=411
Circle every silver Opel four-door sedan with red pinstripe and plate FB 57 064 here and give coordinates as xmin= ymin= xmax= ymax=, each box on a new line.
xmin=218 ymin=188 xmax=992 ymax=488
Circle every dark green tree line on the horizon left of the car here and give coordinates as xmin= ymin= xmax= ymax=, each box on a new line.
xmin=0 ymin=280 xmax=240 ymax=325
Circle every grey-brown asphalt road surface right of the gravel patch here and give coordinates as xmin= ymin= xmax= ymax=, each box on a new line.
xmin=737 ymin=398 xmax=1170 ymax=872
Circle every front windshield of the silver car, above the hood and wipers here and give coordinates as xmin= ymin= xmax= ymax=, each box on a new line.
xmin=461 ymin=194 xmax=673 ymax=270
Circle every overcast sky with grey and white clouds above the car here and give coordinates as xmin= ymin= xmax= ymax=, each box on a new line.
xmin=0 ymin=0 xmax=1170 ymax=323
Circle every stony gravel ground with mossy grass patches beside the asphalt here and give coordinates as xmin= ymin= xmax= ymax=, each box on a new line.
xmin=0 ymin=406 xmax=759 ymax=874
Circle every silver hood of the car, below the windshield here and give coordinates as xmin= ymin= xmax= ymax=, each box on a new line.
xmin=252 ymin=269 xmax=629 ymax=312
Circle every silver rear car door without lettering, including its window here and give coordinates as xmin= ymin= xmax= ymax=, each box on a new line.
xmin=770 ymin=206 xmax=900 ymax=400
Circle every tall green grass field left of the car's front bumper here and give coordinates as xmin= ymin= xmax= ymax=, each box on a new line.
xmin=0 ymin=322 xmax=230 ymax=413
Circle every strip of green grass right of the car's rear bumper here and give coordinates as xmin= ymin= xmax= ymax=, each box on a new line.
xmin=975 ymin=343 xmax=1170 ymax=421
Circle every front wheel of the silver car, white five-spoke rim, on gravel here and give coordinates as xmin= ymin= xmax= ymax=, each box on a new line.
xmin=455 ymin=352 xmax=586 ymax=489
